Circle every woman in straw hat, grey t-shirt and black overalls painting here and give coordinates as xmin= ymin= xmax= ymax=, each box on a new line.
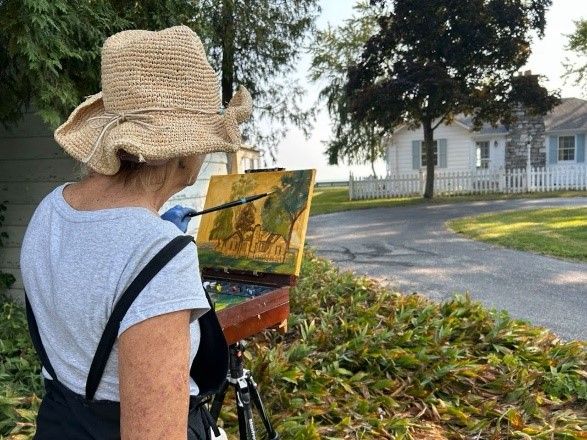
xmin=21 ymin=26 xmax=251 ymax=440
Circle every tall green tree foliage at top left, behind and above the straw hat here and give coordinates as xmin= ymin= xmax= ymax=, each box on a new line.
xmin=0 ymin=0 xmax=319 ymax=156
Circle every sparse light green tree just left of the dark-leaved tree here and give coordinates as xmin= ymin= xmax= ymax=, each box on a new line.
xmin=310 ymin=0 xmax=385 ymax=175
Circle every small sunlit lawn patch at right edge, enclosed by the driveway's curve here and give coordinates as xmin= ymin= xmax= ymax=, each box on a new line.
xmin=448 ymin=208 xmax=587 ymax=261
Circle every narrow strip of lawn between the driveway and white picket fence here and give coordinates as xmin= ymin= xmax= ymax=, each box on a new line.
xmin=310 ymin=187 xmax=587 ymax=215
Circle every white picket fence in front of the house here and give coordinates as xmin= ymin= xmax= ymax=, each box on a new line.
xmin=349 ymin=165 xmax=587 ymax=200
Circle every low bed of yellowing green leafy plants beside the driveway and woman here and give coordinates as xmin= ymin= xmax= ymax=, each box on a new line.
xmin=0 ymin=250 xmax=587 ymax=440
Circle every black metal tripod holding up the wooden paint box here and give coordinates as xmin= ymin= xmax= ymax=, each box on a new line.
xmin=210 ymin=341 xmax=279 ymax=440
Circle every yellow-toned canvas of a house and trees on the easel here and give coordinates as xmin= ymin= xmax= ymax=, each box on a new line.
xmin=196 ymin=169 xmax=316 ymax=276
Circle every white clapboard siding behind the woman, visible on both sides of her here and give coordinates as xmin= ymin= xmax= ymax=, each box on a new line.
xmin=0 ymin=113 xmax=227 ymax=298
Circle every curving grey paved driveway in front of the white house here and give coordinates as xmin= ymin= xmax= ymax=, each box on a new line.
xmin=306 ymin=197 xmax=587 ymax=340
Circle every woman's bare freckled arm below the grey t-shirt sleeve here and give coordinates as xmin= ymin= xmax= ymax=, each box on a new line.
xmin=118 ymin=310 xmax=191 ymax=440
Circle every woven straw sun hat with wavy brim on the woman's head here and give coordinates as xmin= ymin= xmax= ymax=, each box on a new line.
xmin=55 ymin=26 xmax=252 ymax=175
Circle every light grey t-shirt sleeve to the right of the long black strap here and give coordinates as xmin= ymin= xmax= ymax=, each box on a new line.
xmin=118 ymin=237 xmax=210 ymax=336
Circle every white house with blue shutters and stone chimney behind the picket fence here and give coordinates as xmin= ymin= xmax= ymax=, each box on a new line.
xmin=385 ymin=98 xmax=587 ymax=175
